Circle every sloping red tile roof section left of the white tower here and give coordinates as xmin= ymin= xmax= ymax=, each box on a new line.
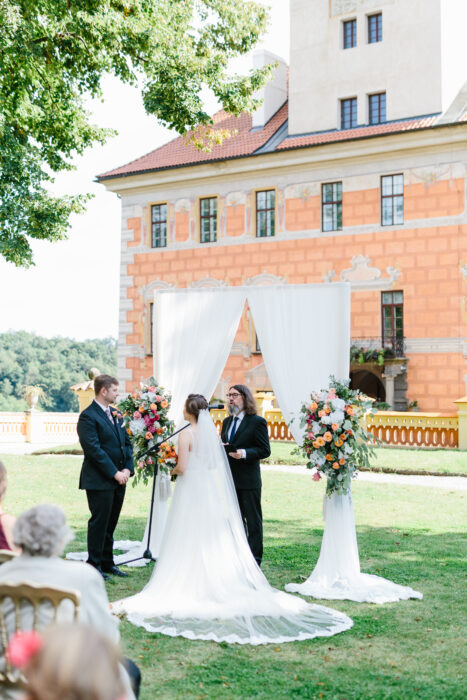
xmin=98 ymin=102 xmax=288 ymax=180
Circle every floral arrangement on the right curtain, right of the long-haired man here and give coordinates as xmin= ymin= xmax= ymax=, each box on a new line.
xmin=298 ymin=377 xmax=374 ymax=496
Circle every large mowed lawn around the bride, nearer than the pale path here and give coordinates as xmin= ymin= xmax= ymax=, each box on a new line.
xmin=0 ymin=453 xmax=467 ymax=700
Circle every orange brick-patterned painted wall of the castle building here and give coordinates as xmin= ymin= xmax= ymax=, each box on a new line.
xmin=117 ymin=171 xmax=467 ymax=413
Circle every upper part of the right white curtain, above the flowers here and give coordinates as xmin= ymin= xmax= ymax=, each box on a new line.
xmin=248 ymin=283 xmax=350 ymax=443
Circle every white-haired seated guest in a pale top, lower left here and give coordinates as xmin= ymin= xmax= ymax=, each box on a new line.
xmin=0 ymin=504 xmax=141 ymax=698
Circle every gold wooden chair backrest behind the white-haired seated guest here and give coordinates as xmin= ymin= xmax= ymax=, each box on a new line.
xmin=0 ymin=583 xmax=80 ymax=688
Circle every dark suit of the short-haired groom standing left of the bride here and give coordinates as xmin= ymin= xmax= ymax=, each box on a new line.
xmin=77 ymin=401 xmax=134 ymax=571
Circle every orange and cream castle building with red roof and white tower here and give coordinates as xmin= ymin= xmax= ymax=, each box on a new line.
xmin=99 ymin=0 xmax=467 ymax=412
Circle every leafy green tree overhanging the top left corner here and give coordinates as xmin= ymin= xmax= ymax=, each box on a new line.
xmin=0 ymin=0 xmax=271 ymax=267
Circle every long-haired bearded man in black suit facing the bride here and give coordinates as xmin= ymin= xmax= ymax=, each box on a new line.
xmin=221 ymin=384 xmax=271 ymax=566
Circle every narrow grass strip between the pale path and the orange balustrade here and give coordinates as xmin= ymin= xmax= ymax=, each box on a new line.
xmin=266 ymin=442 xmax=467 ymax=476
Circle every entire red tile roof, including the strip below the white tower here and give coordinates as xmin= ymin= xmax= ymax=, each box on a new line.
xmin=98 ymin=102 xmax=467 ymax=180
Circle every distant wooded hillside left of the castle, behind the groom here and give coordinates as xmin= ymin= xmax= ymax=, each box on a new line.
xmin=0 ymin=331 xmax=117 ymax=411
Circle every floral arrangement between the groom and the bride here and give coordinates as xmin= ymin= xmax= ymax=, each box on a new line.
xmin=118 ymin=377 xmax=177 ymax=486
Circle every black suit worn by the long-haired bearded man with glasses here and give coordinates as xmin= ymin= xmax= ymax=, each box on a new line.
xmin=221 ymin=413 xmax=271 ymax=564
